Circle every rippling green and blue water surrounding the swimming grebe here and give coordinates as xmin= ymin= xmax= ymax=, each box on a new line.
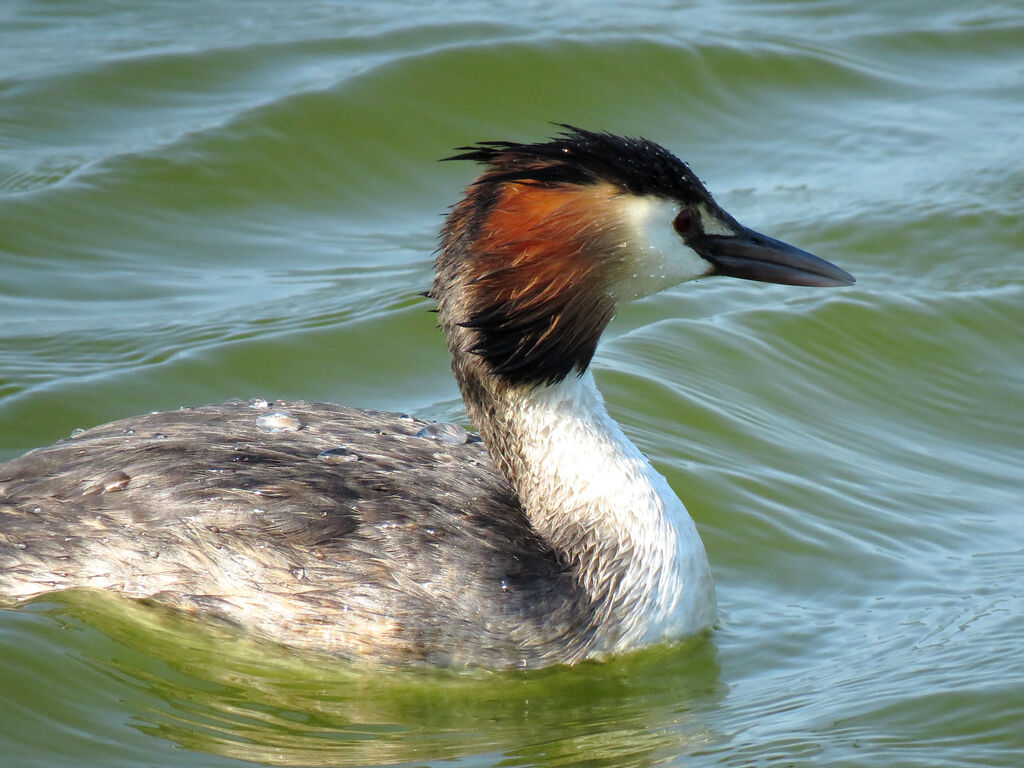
xmin=0 ymin=0 xmax=1024 ymax=768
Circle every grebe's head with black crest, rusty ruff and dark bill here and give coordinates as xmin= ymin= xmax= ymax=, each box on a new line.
xmin=430 ymin=125 xmax=854 ymax=386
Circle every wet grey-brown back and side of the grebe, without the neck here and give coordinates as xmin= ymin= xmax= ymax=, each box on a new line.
xmin=0 ymin=402 xmax=596 ymax=667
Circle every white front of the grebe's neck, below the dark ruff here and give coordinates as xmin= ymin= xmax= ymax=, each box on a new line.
xmin=506 ymin=371 xmax=715 ymax=652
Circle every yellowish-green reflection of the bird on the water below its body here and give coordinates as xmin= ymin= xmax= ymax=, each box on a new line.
xmin=33 ymin=590 xmax=724 ymax=766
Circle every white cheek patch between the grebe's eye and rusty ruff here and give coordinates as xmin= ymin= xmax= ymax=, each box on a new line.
xmin=620 ymin=197 xmax=713 ymax=299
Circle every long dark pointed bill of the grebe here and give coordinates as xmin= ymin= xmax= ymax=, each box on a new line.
xmin=689 ymin=227 xmax=856 ymax=288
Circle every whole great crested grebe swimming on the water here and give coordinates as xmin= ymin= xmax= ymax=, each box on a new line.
xmin=0 ymin=126 xmax=854 ymax=668
